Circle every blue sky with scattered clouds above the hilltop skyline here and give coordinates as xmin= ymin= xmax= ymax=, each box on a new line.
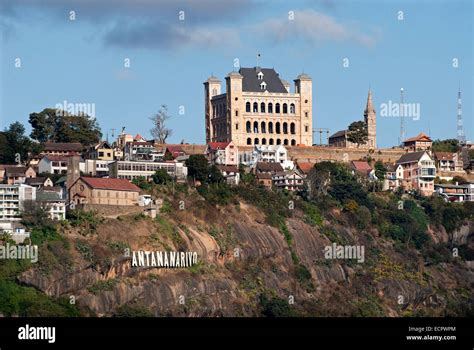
xmin=0 ymin=0 xmax=474 ymax=148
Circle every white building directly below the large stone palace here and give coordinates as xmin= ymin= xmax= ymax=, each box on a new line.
xmin=240 ymin=145 xmax=294 ymax=170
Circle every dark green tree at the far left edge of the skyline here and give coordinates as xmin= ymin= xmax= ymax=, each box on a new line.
xmin=0 ymin=122 xmax=33 ymax=164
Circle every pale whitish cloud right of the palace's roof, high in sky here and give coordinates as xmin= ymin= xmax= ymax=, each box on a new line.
xmin=255 ymin=10 xmax=376 ymax=47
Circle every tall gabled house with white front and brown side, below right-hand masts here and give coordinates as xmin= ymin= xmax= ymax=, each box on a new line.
xmin=396 ymin=151 xmax=436 ymax=196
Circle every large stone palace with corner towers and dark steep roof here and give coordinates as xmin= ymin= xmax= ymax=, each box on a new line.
xmin=204 ymin=67 xmax=313 ymax=147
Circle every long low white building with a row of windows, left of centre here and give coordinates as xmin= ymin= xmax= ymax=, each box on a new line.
xmin=109 ymin=161 xmax=188 ymax=181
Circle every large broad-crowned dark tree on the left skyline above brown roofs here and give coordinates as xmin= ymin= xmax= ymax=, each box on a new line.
xmin=29 ymin=108 xmax=102 ymax=146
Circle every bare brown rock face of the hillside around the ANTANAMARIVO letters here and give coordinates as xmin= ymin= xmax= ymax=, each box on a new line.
xmin=18 ymin=200 xmax=474 ymax=317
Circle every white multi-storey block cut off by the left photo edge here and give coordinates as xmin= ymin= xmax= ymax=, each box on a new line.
xmin=0 ymin=184 xmax=36 ymax=221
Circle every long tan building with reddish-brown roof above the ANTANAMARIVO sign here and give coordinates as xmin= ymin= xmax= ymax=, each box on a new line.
xmin=69 ymin=176 xmax=140 ymax=206
